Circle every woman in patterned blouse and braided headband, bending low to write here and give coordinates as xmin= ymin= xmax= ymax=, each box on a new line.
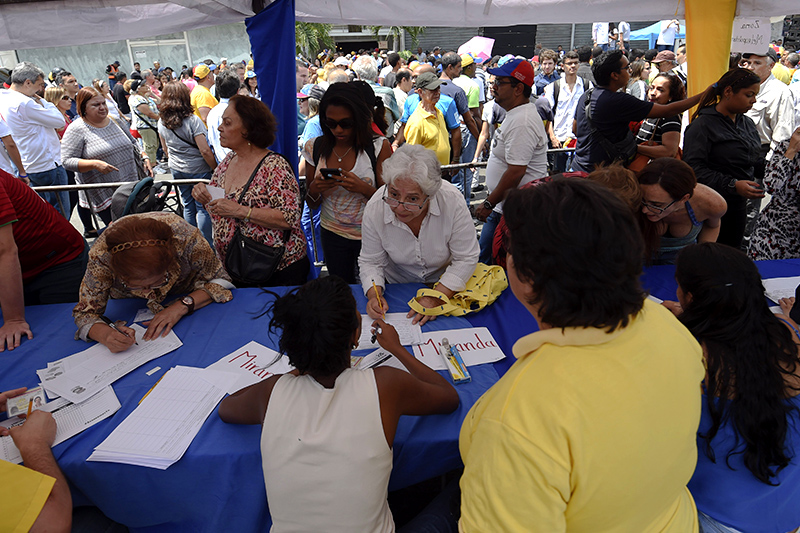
xmin=72 ymin=212 xmax=233 ymax=353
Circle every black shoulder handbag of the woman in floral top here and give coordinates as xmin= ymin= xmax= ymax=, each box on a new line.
xmin=225 ymin=152 xmax=292 ymax=287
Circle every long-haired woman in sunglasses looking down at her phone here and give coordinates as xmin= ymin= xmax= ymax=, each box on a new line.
xmin=305 ymin=83 xmax=392 ymax=284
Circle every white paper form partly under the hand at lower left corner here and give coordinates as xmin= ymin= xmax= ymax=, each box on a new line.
xmin=0 ymin=387 xmax=120 ymax=464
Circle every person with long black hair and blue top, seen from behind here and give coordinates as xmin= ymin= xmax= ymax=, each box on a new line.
xmin=664 ymin=243 xmax=800 ymax=532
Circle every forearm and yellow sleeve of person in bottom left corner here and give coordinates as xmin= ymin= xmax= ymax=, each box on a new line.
xmin=0 ymin=387 xmax=72 ymax=532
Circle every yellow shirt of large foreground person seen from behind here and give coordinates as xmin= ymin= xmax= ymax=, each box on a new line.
xmin=459 ymin=300 xmax=705 ymax=533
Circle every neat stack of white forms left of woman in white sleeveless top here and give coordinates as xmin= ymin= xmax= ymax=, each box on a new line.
xmin=87 ymin=366 xmax=239 ymax=470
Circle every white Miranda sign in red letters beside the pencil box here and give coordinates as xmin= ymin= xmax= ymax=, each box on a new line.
xmin=414 ymin=328 xmax=505 ymax=370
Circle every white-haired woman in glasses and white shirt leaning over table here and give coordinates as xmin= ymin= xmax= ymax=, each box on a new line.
xmin=358 ymin=144 xmax=479 ymax=324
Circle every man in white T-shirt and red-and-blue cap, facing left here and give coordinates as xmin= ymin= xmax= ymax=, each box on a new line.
xmin=475 ymin=59 xmax=547 ymax=264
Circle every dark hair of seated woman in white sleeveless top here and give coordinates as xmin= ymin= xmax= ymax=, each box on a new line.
xmin=262 ymin=276 xmax=361 ymax=376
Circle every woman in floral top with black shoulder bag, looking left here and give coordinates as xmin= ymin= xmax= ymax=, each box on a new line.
xmin=192 ymin=95 xmax=310 ymax=286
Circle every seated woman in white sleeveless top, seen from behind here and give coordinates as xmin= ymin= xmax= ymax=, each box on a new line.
xmin=219 ymin=274 xmax=456 ymax=533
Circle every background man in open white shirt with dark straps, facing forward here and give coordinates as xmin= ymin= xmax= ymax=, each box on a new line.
xmin=544 ymin=50 xmax=592 ymax=172
